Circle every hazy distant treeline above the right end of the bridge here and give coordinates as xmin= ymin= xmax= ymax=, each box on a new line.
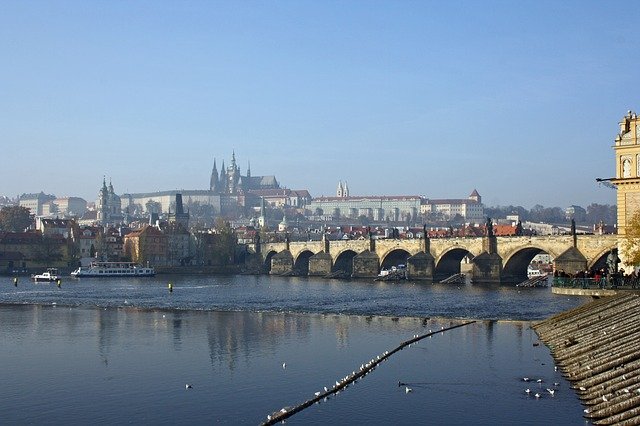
xmin=484 ymin=203 xmax=617 ymax=225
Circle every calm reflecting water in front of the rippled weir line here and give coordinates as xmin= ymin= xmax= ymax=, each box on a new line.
xmin=0 ymin=305 xmax=581 ymax=424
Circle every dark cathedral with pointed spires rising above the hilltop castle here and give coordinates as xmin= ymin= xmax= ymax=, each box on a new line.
xmin=209 ymin=152 xmax=280 ymax=195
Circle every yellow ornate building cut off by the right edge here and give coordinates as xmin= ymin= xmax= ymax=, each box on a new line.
xmin=611 ymin=111 xmax=640 ymax=269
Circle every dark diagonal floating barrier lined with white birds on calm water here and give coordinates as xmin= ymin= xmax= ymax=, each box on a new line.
xmin=262 ymin=321 xmax=476 ymax=426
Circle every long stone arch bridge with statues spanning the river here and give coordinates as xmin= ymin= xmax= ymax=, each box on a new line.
xmin=250 ymin=235 xmax=617 ymax=283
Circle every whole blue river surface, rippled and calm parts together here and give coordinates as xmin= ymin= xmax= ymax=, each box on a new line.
xmin=0 ymin=276 xmax=586 ymax=425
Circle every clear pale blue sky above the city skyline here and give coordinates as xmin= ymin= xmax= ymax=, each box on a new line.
xmin=0 ymin=0 xmax=640 ymax=208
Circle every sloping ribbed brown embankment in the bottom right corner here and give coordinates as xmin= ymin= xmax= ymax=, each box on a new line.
xmin=533 ymin=294 xmax=640 ymax=425
